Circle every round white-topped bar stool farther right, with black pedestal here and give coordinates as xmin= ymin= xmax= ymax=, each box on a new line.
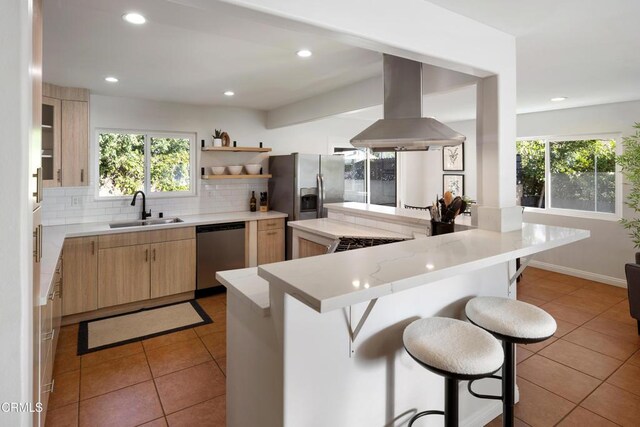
xmin=465 ymin=297 xmax=557 ymax=426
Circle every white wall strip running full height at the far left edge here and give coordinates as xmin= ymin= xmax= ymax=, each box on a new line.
xmin=0 ymin=0 xmax=33 ymax=426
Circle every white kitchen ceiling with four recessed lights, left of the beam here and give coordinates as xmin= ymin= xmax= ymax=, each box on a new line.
xmin=44 ymin=0 xmax=382 ymax=110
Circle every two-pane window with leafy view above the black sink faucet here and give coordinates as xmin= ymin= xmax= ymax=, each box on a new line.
xmin=98 ymin=130 xmax=195 ymax=197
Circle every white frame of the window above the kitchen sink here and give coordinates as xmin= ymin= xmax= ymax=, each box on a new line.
xmin=93 ymin=128 xmax=198 ymax=201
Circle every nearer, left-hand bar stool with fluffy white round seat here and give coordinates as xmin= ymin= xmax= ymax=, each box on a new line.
xmin=402 ymin=317 xmax=504 ymax=427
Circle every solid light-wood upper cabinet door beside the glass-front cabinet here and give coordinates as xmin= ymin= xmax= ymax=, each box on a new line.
xmin=61 ymin=100 xmax=89 ymax=187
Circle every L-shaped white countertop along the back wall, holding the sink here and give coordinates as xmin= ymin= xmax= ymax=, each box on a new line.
xmin=39 ymin=211 xmax=287 ymax=305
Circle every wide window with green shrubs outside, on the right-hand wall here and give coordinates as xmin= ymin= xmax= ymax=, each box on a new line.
xmin=516 ymin=138 xmax=619 ymax=214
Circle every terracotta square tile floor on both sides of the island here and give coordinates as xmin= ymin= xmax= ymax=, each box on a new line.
xmin=47 ymin=268 xmax=640 ymax=427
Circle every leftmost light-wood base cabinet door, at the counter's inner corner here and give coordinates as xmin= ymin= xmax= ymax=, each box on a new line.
xmin=62 ymin=236 xmax=98 ymax=316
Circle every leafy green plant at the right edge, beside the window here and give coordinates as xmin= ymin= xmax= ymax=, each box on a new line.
xmin=617 ymin=123 xmax=640 ymax=264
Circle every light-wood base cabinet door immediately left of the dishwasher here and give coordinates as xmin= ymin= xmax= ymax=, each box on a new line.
xmin=151 ymin=239 xmax=196 ymax=298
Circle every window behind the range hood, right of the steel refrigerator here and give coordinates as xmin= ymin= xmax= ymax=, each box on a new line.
xmin=333 ymin=147 xmax=397 ymax=206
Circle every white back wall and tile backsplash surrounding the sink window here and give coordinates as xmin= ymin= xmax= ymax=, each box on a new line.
xmin=43 ymin=95 xmax=369 ymax=225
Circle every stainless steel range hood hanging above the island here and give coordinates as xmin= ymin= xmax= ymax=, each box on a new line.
xmin=351 ymin=54 xmax=467 ymax=151
